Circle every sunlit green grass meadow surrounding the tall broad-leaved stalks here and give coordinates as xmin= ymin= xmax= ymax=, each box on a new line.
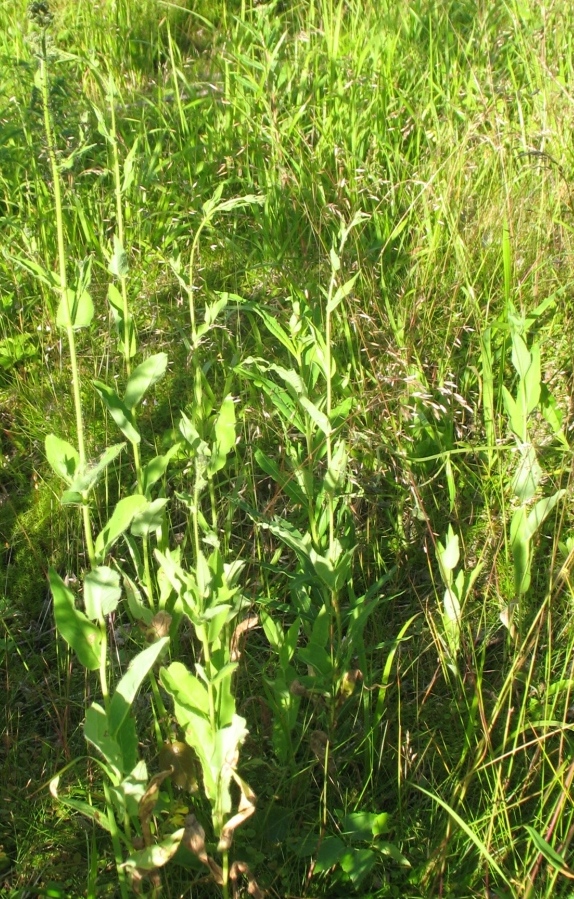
xmin=0 ymin=0 xmax=574 ymax=899
